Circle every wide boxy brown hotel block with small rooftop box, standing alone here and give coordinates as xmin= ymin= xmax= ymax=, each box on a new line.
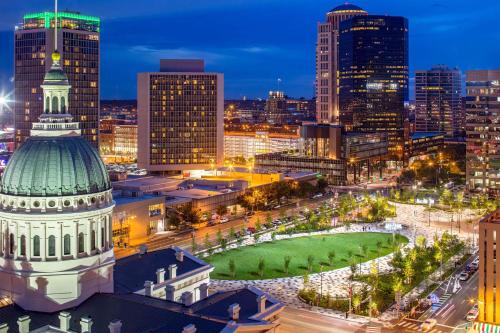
xmin=137 ymin=60 xmax=224 ymax=173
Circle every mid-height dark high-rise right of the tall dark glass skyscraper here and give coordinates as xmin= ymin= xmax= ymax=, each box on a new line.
xmin=415 ymin=65 xmax=462 ymax=137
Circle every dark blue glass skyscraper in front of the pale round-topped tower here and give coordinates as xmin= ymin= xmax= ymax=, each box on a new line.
xmin=339 ymin=15 xmax=408 ymax=158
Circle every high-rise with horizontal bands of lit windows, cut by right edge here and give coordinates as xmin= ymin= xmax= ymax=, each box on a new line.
xmin=466 ymin=70 xmax=500 ymax=196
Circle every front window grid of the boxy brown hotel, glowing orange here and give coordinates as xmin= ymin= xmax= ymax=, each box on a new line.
xmin=149 ymin=74 xmax=218 ymax=165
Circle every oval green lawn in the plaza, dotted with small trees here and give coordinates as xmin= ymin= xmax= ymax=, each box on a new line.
xmin=204 ymin=232 xmax=408 ymax=280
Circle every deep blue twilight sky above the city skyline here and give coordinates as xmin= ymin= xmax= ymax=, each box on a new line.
xmin=0 ymin=0 xmax=500 ymax=99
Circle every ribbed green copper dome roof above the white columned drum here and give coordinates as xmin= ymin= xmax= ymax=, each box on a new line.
xmin=1 ymin=136 xmax=111 ymax=197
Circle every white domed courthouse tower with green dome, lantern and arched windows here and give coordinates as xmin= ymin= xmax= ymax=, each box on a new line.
xmin=0 ymin=52 xmax=115 ymax=312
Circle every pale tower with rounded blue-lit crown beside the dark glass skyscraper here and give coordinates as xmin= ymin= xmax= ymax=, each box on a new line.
xmin=316 ymin=4 xmax=368 ymax=124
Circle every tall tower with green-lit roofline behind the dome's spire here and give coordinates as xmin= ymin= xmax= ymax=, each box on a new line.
xmin=14 ymin=12 xmax=100 ymax=148
